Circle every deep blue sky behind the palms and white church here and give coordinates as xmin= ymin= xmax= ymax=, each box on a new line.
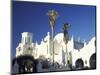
xmin=12 ymin=1 xmax=96 ymax=56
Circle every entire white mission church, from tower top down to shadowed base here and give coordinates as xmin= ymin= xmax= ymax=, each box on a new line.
xmin=13 ymin=32 xmax=96 ymax=73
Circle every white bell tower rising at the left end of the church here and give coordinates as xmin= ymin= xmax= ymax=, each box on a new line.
xmin=16 ymin=32 xmax=34 ymax=57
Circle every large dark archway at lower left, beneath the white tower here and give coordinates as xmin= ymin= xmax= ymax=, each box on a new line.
xmin=12 ymin=55 xmax=38 ymax=74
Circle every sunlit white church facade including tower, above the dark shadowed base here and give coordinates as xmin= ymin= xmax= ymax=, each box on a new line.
xmin=16 ymin=32 xmax=96 ymax=71
